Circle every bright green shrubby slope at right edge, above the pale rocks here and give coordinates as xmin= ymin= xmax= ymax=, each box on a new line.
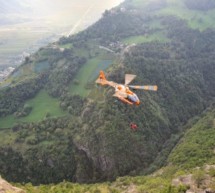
xmin=168 ymin=109 xmax=215 ymax=169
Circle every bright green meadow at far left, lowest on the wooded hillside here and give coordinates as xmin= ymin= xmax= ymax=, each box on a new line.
xmin=0 ymin=90 xmax=67 ymax=128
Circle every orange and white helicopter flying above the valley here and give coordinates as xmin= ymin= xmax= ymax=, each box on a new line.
xmin=96 ymin=71 xmax=158 ymax=105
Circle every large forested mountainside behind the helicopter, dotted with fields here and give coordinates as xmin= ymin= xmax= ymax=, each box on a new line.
xmin=0 ymin=1 xmax=215 ymax=184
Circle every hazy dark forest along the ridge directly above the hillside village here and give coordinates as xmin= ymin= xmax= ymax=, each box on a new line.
xmin=66 ymin=9 xmax=151 ymax=47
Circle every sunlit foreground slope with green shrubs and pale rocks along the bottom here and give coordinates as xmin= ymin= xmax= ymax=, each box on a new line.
xmin=17 ymin=106 xmax=215 ymax=193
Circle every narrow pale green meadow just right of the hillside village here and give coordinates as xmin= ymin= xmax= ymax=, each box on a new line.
xmin=123 ymin=32 xmax=169 ymax=44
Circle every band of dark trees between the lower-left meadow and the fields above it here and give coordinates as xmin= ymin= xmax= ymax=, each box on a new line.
xmin=0 ymin=48 xmax=86 ymax=117
